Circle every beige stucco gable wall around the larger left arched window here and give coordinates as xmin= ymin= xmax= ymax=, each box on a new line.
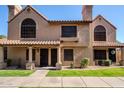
xmin=8 ymin=10 xmax=59 ymax=40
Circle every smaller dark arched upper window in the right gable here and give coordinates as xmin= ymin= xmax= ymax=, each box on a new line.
xmin=94 ymin=25 xmax=106 ymax=41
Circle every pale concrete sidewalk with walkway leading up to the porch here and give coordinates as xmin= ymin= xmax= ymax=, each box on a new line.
xmin=0 ymin=70 xmax=124 ymax=88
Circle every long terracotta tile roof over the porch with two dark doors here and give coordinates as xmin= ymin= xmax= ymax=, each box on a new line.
xmin=0 ymin=39 xmax=60 ymax=45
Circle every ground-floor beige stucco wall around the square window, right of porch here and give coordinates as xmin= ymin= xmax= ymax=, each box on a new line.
xmin=61 ymin=47 xmax=92 ymax=67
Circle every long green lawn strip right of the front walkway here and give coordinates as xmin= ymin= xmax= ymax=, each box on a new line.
xmin=47 ymin=68 xmax=124 ymax=77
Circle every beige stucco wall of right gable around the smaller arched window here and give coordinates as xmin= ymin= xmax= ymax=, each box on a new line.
xmin=91 ymin=16 xmax=116 ymax=42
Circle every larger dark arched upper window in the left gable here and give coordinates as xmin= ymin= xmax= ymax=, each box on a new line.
xmin=21 ymin=18 xmax=36 ymax=38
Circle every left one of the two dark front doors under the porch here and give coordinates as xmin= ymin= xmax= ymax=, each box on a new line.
xmin=40 ymin=49 xmax=48 ymax=67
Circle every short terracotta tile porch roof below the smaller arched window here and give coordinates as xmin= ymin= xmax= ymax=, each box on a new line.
xmin=93 ymin=41 xmax=124 ymax=47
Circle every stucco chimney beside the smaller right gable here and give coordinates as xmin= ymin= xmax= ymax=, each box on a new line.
xmin=82 ymin=5 xmax=93 ymax=21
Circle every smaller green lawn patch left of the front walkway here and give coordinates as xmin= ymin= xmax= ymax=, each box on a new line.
xmin=0 ymin=70 xmax=34 ymax=77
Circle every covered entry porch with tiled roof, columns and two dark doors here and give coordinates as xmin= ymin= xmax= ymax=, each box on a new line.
xmin=0 ymin=40 xmax=62 ymax=69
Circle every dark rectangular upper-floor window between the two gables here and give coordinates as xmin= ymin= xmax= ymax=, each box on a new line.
xmin=61 ymin=26 xmax=77 ymax=37
